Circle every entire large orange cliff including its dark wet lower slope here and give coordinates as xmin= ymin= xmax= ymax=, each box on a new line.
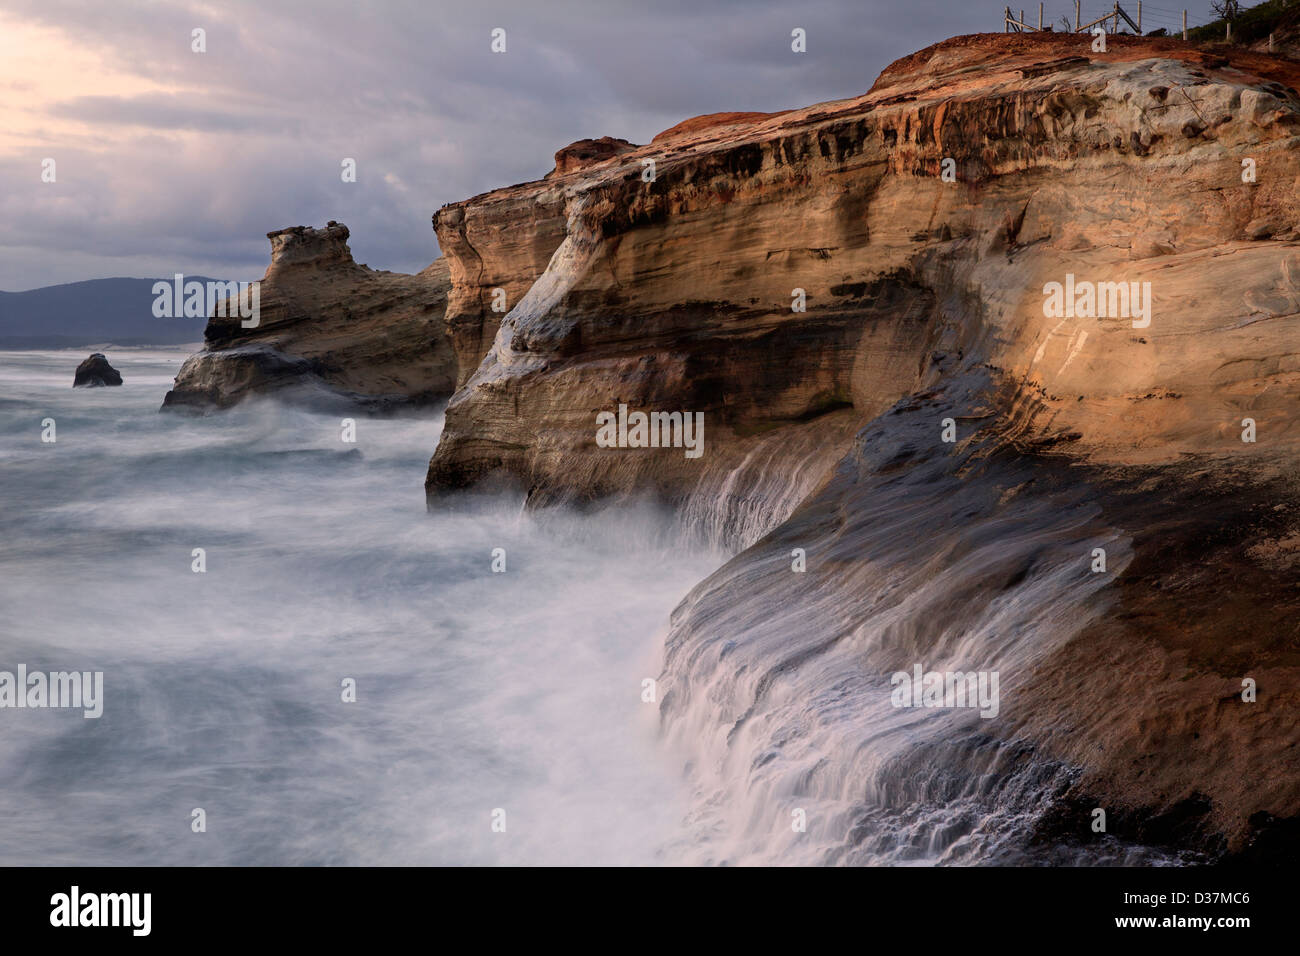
xmin=426 ymin=34 xmax=1300 ymax=858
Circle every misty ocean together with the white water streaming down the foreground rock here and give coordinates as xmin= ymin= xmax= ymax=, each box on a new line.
xmin=0 ymin=350 xmax=1187 ymax=865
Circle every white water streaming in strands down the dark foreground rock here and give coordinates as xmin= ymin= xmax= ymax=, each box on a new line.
xmin=663 ymin=379 xmax=1149 ymax=864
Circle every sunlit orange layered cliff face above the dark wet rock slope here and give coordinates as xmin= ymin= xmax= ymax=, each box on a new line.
xmin=429 ymin=35 xmax=1300 ymax=515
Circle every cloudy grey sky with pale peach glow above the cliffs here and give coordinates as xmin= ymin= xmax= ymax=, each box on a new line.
xmin=0 ymin=0 xmax=1216 ymax=291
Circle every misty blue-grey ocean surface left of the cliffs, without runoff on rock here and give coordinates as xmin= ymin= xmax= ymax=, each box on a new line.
xmin=0 ymin=349 xmax=723 ymax=865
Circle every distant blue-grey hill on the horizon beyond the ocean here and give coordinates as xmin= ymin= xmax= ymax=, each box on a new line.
xmin=0 ymin=276 xmax=223 ymax=349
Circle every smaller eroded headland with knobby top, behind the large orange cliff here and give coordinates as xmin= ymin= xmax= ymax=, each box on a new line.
xmin=164 ymin=222 xmax=458 ymax=410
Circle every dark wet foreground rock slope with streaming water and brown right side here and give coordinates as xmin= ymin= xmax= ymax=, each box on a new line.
xmin=662 ymin=369 xmax=1296 ymax=865
